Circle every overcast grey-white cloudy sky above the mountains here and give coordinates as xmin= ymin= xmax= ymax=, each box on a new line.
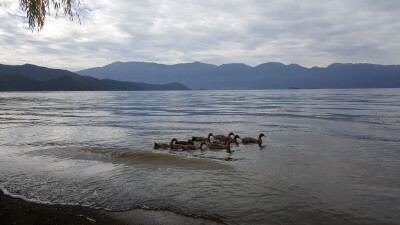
xmin=0 ymin=0 xmax=400 ymax=71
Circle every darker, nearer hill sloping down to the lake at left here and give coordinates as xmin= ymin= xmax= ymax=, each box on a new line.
xmin=0 ymin=64 xmax=189 ymax=91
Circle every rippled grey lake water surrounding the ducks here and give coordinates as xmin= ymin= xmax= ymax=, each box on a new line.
xmin=0 ymin=89 xmax=400 ymax=224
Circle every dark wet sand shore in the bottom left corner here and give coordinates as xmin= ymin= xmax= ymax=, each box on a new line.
xmin=0 ymin=190 xmax=221 ymax=225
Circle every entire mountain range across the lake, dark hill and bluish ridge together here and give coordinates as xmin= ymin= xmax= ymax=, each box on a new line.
xmin=0 ymin=62 xmax=400 ymax=91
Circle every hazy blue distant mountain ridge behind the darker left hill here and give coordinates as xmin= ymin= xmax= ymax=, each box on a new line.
xmin=77 ymin=62 xmax=400 ymax=89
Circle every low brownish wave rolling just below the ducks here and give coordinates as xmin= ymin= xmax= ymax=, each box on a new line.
xmin=27 ymin=147 xmax=232 ymax=170
